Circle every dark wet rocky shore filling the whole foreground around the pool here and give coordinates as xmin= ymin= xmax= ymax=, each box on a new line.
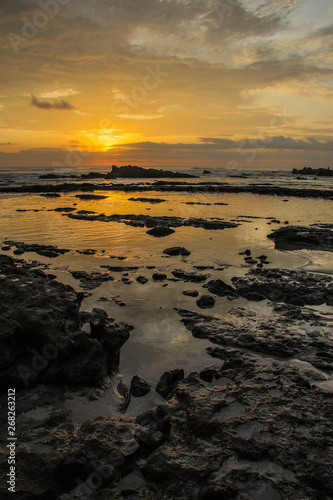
xmin=0 ymin=247 xmax=333 ymax=500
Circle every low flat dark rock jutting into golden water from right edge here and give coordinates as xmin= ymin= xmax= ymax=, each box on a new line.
xmin=267 ymin=226 xmax=333 ymax=252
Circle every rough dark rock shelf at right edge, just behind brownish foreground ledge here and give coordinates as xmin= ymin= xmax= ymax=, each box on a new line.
xmin=232 ymin=268 xmax=333 ymax=305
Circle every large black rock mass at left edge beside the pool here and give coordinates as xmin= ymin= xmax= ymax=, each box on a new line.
xmin=0 ymin=256 xmax=129 ymax=390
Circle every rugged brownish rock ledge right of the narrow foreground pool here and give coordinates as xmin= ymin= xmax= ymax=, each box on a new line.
xmin=176 ymin=305 xmax=333 ymax=371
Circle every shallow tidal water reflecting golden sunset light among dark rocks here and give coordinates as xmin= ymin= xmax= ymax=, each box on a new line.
xmin=0 ymin=168 xmax=333 ymax=390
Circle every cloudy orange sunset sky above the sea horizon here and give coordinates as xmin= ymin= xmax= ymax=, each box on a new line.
xmin=0 ymin=0 xmax=333 ymax=169
